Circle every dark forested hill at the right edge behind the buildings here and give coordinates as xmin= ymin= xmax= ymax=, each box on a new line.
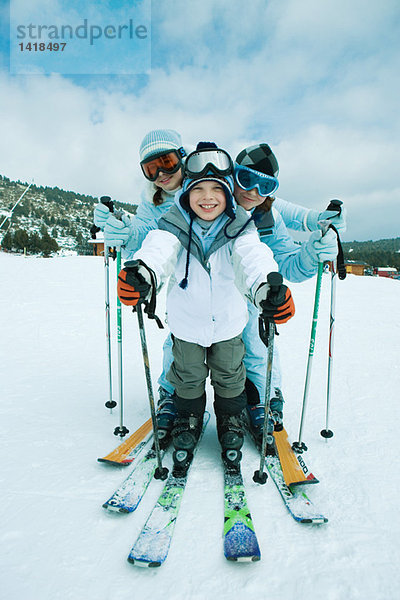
xmin=343 ymin=237 xmax=400 ymax=270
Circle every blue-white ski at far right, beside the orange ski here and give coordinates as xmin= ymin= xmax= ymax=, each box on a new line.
xmin=265 ymin=456 xmax=328 ymax=524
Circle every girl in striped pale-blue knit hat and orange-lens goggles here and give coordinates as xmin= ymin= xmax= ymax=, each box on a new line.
xmin=94 ymin=129 xmax=346 ymax=446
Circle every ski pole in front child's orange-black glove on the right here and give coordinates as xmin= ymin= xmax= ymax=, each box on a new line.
xmin=253 ymin=272 xmax=283 ymax=484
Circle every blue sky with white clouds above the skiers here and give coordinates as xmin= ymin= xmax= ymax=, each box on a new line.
xmin=0 ymin=0 xmax=400 ymax=241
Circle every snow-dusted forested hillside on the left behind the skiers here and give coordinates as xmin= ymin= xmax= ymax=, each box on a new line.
xmin=0 ymin=175 xmax=137 ymax=255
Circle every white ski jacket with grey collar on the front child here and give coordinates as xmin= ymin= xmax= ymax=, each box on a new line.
xmin=134 ymin=205 xmax=278 ymax=347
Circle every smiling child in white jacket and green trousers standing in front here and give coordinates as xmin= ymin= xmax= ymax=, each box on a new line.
xmin=118 ymin=143 xmax=294 ymax=468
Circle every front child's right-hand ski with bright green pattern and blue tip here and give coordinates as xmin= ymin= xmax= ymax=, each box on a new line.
xmin=223 ymin=450 xmax=261 ymax=561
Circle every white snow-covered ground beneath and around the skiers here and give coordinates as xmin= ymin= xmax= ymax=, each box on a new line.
xmin=0 ymin=252 xmax=400 ymax=600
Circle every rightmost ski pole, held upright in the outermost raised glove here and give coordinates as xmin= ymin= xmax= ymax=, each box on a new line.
xmin=320 ymin=200 xmax=346 ymax=440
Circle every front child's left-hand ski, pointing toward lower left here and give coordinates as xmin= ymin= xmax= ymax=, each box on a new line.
xmin=128 ymin=412 xmax=210 ymax=567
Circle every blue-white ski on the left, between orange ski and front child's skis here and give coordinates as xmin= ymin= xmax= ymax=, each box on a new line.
xmin=103 ymin=436 xmax=169 ymax=513
